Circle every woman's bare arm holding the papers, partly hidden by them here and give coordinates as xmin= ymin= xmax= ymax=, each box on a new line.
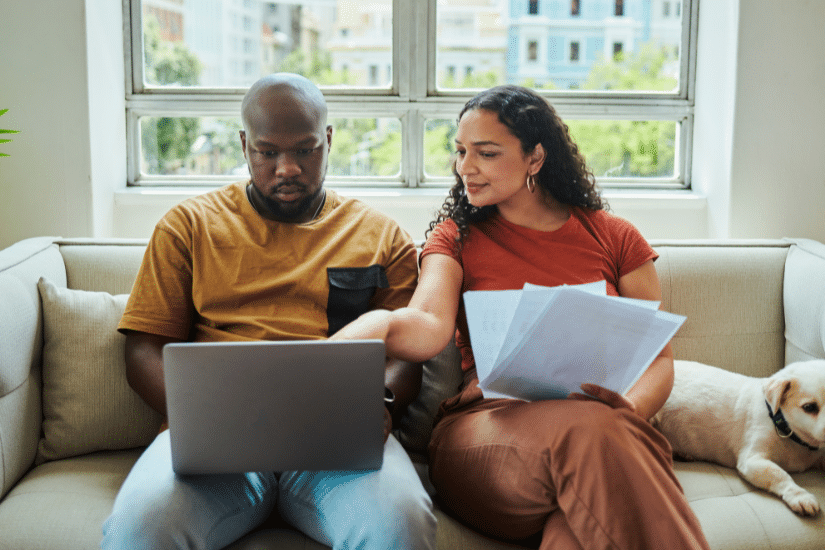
xmin=619 ymin=260 xmax=673 ymax=419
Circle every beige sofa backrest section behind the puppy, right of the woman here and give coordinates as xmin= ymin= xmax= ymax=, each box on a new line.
xmin=651 ymin=240 xmax=791 ymax=377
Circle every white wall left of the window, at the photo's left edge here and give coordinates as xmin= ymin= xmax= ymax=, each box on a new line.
xmin=0 ymin=0 xmax=126 ymax=248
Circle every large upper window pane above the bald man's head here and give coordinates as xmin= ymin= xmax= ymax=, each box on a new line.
xmin=141 ymin=0 xmax=392 ymax=88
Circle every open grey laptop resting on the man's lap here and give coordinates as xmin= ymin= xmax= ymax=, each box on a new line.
xmin=163 ymin=340 xmax=385 ymax=474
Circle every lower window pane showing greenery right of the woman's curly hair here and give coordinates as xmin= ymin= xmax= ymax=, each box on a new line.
xmin=565 ymin=120 xmax=679 ymax=178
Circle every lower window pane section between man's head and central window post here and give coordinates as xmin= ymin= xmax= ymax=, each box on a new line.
xmin=328 ymin=118 xmax=401 ymax=176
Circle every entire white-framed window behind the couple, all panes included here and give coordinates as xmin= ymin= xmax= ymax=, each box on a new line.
xmin=124 ymin=0 xmax=698 ymax=188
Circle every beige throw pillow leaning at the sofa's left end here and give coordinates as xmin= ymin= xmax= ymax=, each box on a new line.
xmin=36 ymin=279 xmax=162 ymax=464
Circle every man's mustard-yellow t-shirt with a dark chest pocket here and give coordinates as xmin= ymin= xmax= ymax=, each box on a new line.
xmin=118 ymin=181 xmax=418 ymax=341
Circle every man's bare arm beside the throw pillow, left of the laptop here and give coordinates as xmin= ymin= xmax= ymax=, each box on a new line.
xmin=125 ymin=330 xmax=182 ymax=416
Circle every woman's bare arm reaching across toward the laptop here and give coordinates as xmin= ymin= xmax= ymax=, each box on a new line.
xmin=332 ymin=254 xmax=464 ymax=362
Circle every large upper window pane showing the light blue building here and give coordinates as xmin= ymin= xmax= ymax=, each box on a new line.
xmin=436 ymin=0 xmax=682 ymax=92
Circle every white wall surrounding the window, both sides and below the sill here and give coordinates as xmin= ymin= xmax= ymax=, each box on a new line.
xmin=0 ymin=0 xmax=825 ymax=248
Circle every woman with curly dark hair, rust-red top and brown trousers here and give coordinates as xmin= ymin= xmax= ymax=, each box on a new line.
xmin=335 ymin=86 xmax=708 ymax=550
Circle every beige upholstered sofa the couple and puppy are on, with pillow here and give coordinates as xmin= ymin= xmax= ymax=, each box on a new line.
xmin=0 ymin=237 xmax=825 ymax=550
